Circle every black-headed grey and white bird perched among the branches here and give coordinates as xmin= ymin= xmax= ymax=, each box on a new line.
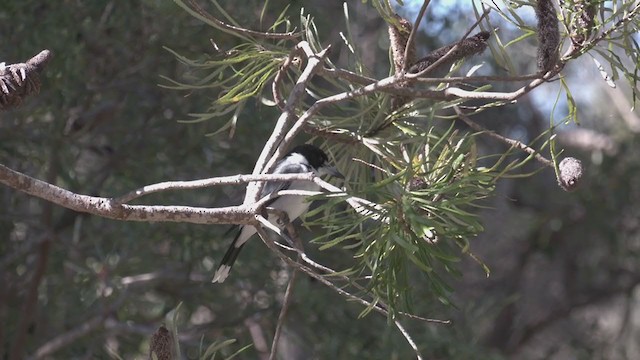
xmin=212 ymin=144 xmax=344 ymax=283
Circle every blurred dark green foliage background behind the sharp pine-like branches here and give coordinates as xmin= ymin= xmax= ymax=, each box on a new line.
xmin=0 ymin=0 xmax=640 ymax=359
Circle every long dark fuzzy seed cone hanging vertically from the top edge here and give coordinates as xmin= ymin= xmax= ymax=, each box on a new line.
xmin=536 ymin=0 xmax=560 ymax=72
